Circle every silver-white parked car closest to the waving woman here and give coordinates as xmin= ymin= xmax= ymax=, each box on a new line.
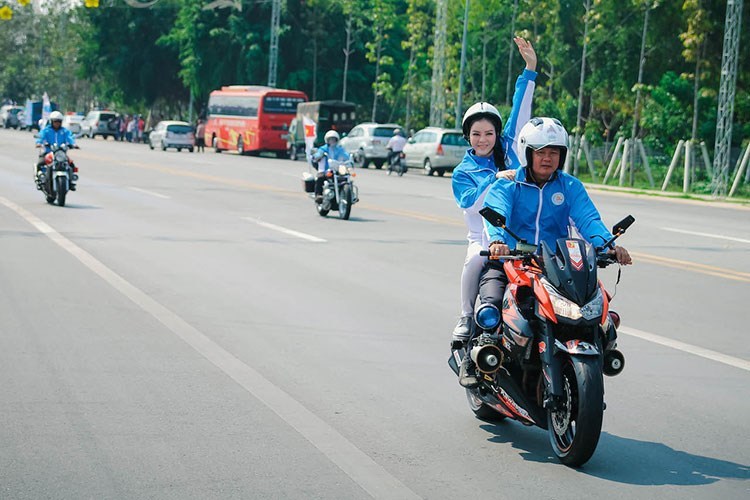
xmin=404 ymin=127 xmax=469 ymax=177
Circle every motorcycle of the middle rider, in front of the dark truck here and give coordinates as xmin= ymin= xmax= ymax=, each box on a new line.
xmin=302 ymin=150 xmax=359 ymax=220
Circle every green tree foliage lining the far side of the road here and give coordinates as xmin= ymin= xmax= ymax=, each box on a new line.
xmin=0 ymin=0 xmax=750 ymax=148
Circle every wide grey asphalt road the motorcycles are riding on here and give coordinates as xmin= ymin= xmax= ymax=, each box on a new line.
xmin=0 ymin=130 xmax=750 ymax=500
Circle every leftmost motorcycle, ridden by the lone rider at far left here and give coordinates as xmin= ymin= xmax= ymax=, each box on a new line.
xmin=34 ymin=143 xmax=79 ymax=207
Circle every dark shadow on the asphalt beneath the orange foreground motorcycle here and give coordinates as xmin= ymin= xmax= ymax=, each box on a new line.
xmin=481 ymin=422 xmax=750 ymax=486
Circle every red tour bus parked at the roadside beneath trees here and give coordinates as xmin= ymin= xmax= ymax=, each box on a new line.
xmin=204 ymin=85 xmax=307 ymax=154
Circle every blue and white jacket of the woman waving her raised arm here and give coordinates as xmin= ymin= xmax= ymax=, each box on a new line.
xmin=452 ymin=69 xmax=537 ymax=241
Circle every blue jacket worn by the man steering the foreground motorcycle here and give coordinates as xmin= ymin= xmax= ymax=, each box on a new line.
xmin=484 ymin=167 xmax=612 ymax=252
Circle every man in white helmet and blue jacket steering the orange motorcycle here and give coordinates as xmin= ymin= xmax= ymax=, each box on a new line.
xmin=459 ymin=118 xmax=632 ymax=387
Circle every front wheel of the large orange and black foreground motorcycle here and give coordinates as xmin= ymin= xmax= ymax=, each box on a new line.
xmin=547 ymin=357 xmax=604 ymax=467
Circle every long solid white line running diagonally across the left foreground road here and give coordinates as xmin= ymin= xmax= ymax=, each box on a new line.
xmin=0 ymin=196 xmax=420 ymax=499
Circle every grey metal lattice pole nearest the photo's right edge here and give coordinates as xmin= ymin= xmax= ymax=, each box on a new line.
xmin=711 ymin=0 xmax=743 ymax=196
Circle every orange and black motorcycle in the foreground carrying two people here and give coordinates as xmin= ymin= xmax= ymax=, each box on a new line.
xmin=448 ymin=207 xmax=635 ymax=467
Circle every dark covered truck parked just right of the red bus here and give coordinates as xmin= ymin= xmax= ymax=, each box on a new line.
xmin=286 ymin=101 xmax=356 ymax=160
